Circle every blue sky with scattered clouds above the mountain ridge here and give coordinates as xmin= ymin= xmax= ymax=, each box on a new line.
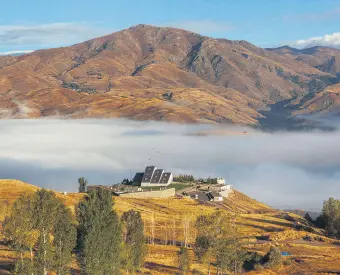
xmin=0 ymin=0 xmax=340 ymax=54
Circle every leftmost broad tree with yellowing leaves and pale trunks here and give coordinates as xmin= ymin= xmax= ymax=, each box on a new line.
xmin=3 ymin=189 xmax=75 ymax=275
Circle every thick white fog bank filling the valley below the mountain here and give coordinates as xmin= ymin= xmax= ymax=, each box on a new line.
xmin=0 ymin=120 xmax=340 ymax=210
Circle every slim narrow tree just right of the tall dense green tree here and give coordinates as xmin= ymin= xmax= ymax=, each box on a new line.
xmin=122 ymin=210 xmax=146 ymax=272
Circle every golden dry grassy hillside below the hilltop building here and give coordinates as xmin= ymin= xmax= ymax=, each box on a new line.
xmin=0 ymin=180 xmax=340 ymax=275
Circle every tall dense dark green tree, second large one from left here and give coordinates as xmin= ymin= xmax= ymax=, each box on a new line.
xmin=77 ymin=189 xmax=122 ymax=275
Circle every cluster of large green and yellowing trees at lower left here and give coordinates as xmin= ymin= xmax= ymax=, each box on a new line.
xmin=3 ymin=189 xmax=146 ymax=275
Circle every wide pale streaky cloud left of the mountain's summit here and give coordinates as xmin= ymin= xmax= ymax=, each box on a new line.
xmin=0 ymin=22 xmax=109 ymax=49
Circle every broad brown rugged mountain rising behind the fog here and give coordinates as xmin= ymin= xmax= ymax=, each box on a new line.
xmin=0 ymin=25 xmax=339 ymax=125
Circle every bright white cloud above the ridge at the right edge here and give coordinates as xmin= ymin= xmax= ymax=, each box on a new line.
xmin=288 ymin=32 xmax=340 ymax=48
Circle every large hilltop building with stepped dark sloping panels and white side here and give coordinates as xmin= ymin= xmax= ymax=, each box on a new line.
xmin=133 ymin=166 xmax=173 ymax=187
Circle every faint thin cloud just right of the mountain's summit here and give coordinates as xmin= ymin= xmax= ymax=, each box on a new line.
xmin=162 ymin=20 xmax=232 ymax=34
